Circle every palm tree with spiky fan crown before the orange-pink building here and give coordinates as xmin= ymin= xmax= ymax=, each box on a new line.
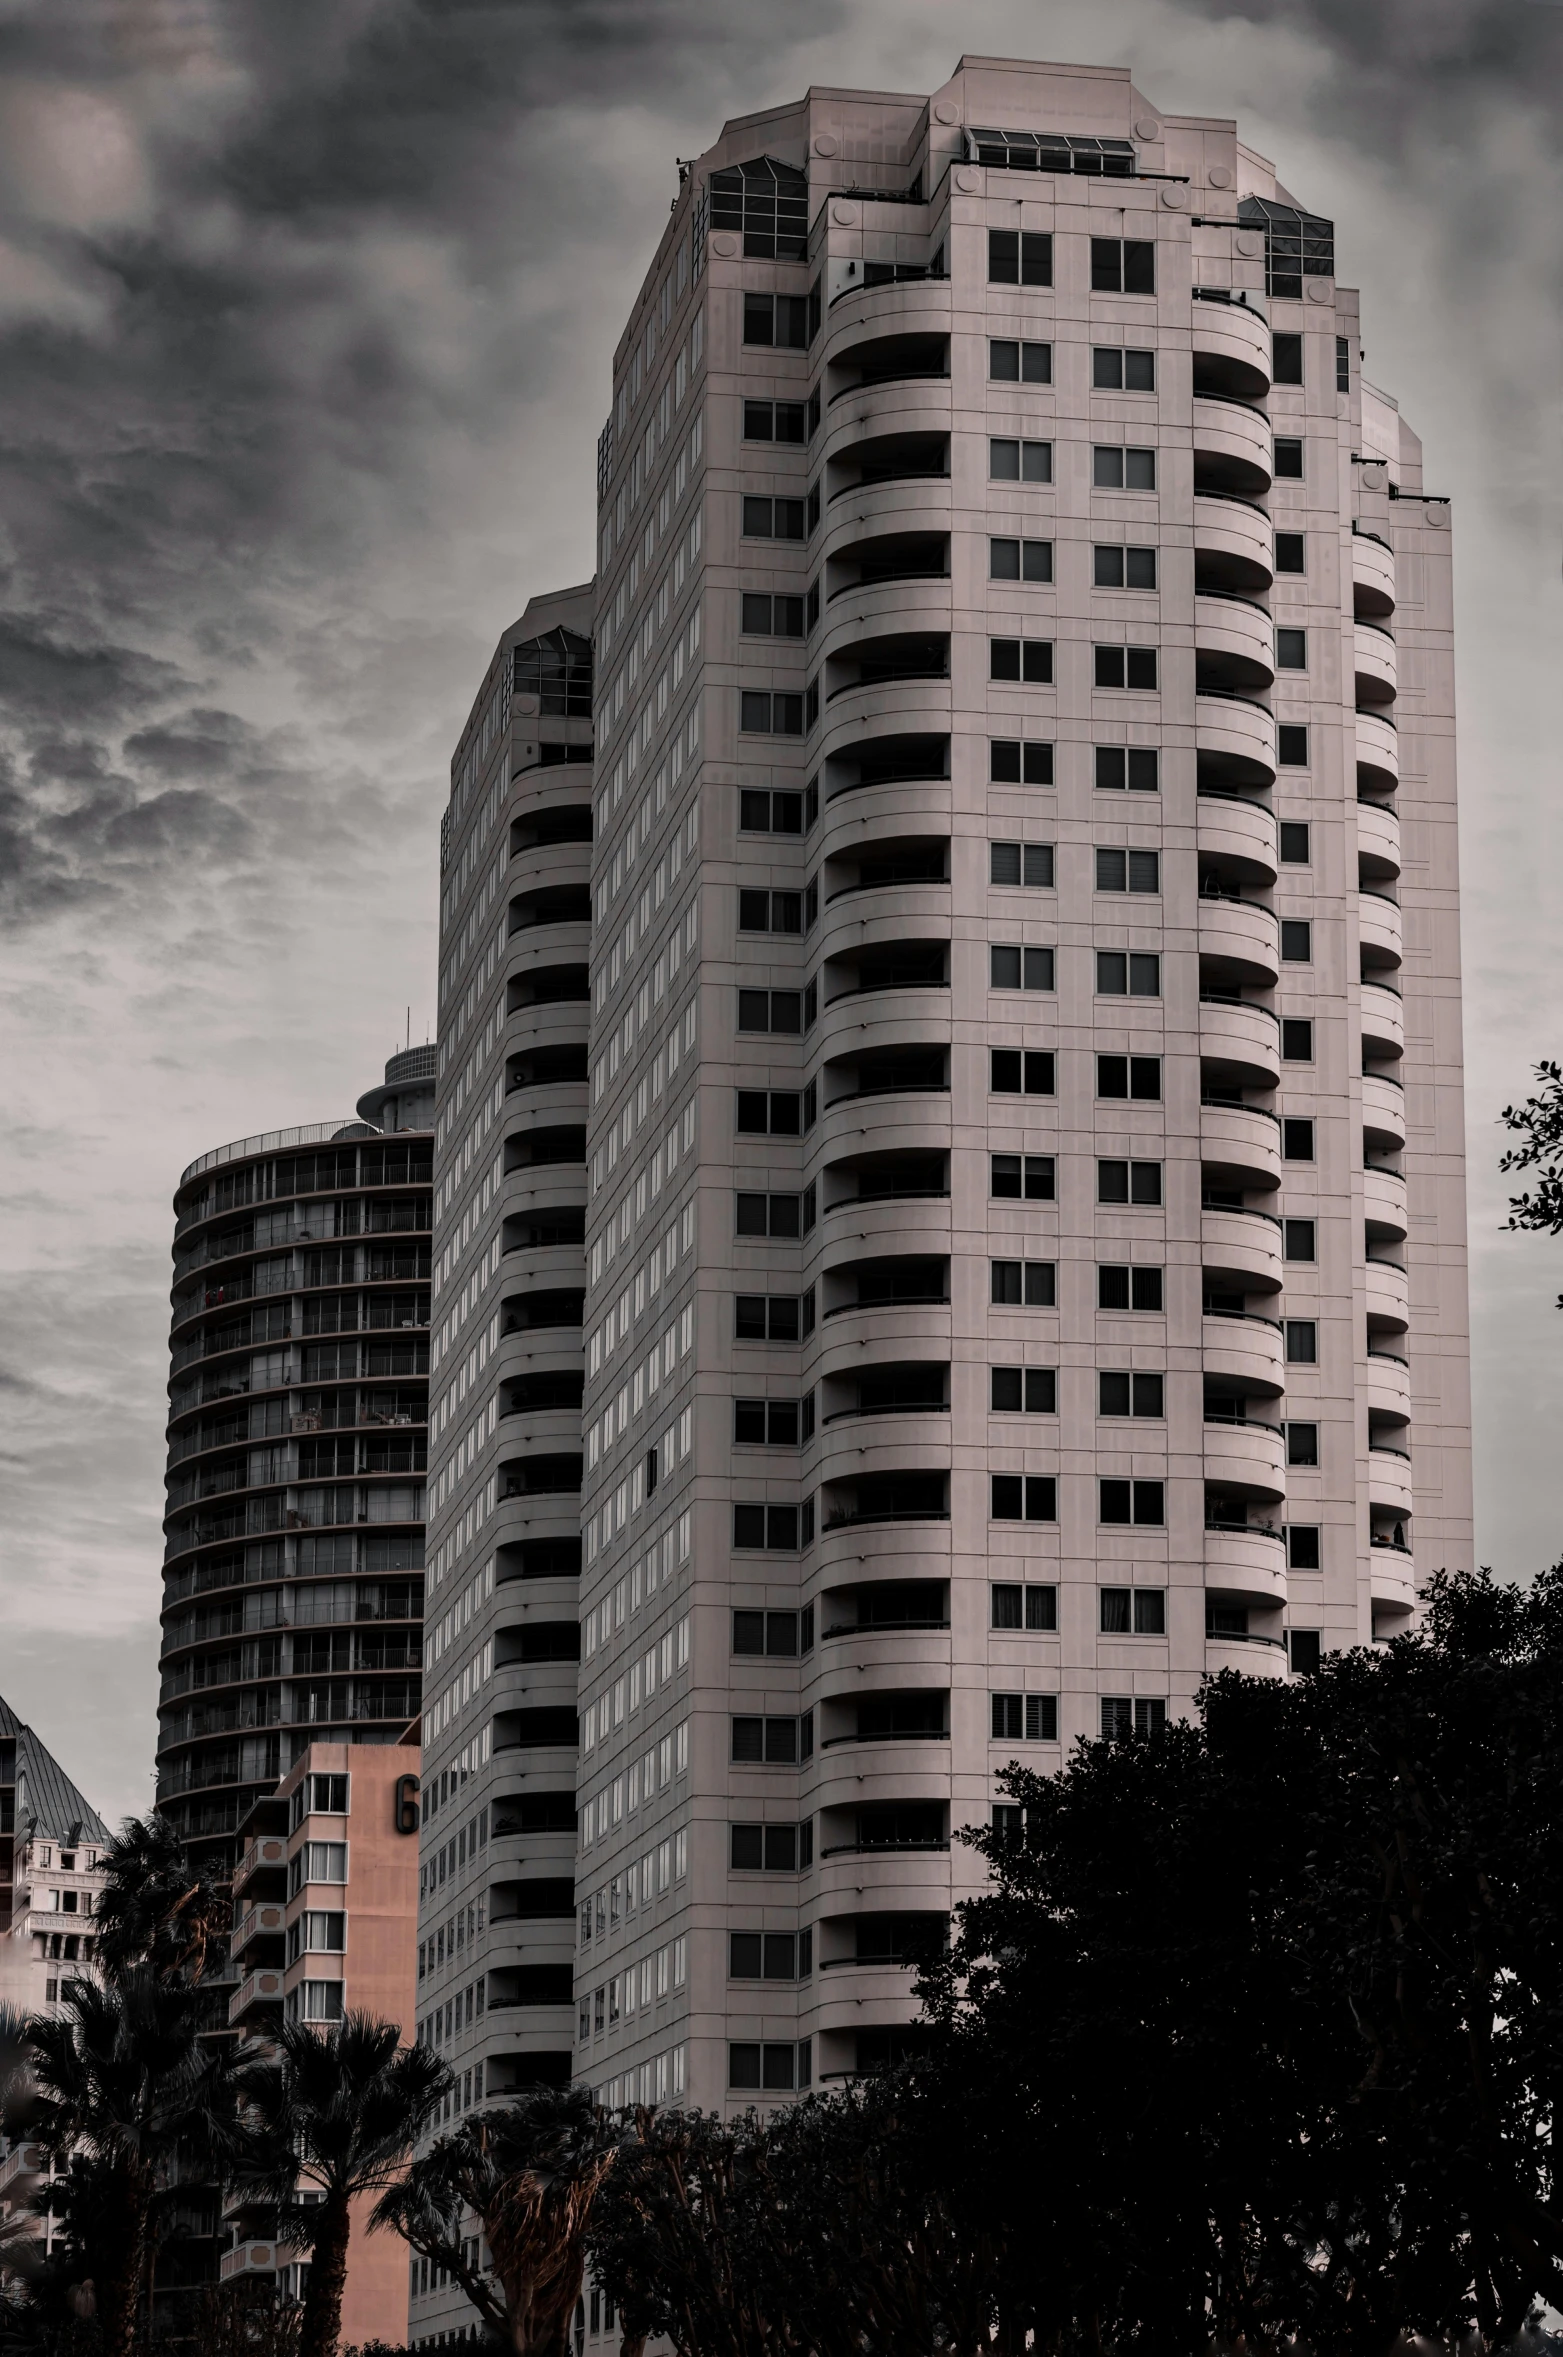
xmin=233 ymin=2013 xmax=450 ymax=2357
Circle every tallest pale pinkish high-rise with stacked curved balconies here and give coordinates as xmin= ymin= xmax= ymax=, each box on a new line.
xmin=415 ymin=59 xmax=1471 ymax=2300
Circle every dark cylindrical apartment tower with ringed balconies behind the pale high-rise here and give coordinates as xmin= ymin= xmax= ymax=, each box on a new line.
xmin=158 ymin=1047 xmax=436 ymax=1867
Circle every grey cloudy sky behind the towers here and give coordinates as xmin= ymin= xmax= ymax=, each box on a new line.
xmin=0 ymin=0 xmax=1563 ymax=1815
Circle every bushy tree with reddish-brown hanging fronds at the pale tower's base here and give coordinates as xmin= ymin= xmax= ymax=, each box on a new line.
xmin=375 ymin=2086 xmax=618 ymax=2357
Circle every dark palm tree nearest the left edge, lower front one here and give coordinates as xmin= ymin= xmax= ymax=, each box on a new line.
xmin=24 ymin=1963 xmax=233 ymax=2357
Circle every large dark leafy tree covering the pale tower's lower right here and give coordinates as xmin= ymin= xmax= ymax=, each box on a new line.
xmin=919 ymin=1567 xmax=1563 ymax=2357
